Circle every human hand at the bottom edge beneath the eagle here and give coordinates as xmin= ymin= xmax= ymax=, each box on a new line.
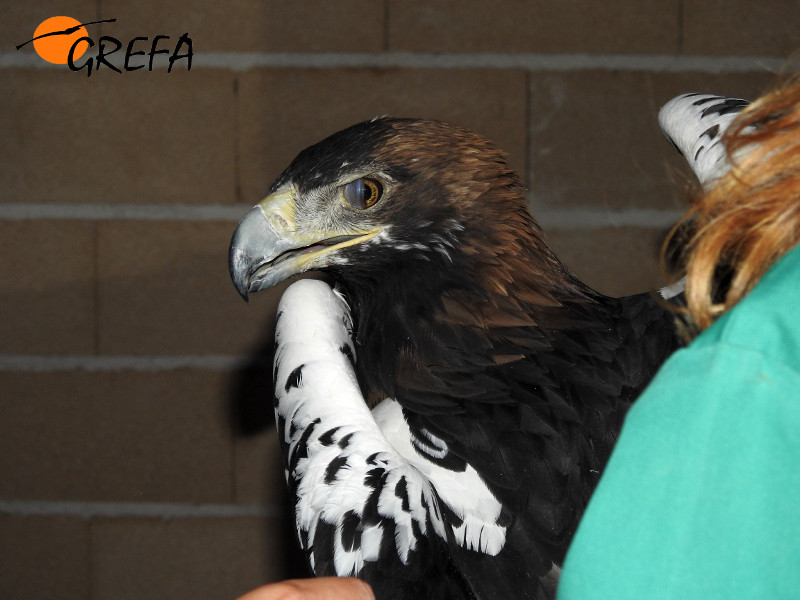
xmin=238 ymin=577 xmax=375 ymax=600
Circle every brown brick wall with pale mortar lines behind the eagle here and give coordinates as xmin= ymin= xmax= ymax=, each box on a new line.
xmin=0 ymin=0 xmax=800 ymax=600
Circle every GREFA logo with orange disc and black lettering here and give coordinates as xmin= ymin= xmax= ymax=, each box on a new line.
xmin=17 ymin=17 xmax=192 ymax=77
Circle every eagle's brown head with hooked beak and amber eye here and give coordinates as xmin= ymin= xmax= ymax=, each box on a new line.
xmin=229 ymin=118 xmax=548 ymax=299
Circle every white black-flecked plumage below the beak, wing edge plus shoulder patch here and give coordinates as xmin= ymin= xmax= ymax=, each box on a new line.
xmin=275 ymin=280 xmax=505 ymax=576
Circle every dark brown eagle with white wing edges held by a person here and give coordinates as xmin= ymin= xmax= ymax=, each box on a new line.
xmin=229 ymin=91 xmax=752 ymax=600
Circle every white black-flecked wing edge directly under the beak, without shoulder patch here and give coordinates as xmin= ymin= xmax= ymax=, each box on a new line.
xmin=275 ymin=280 xmax=441 ymax=576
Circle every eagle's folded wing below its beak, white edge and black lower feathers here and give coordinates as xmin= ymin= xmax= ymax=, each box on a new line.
xmin=274 ymin=280 xmax=484 ymax=598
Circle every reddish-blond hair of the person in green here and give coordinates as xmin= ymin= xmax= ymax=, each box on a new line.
xmin=665 ymin=77 xmax=800 ymax=334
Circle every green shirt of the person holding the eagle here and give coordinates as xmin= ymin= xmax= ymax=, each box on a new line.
xmin=558 ymin=246 xmax=800 ymax=600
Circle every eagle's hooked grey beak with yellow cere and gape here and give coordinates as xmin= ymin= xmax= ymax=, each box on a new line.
xmin=228 ymin=188 xmax=380 ymax=300
